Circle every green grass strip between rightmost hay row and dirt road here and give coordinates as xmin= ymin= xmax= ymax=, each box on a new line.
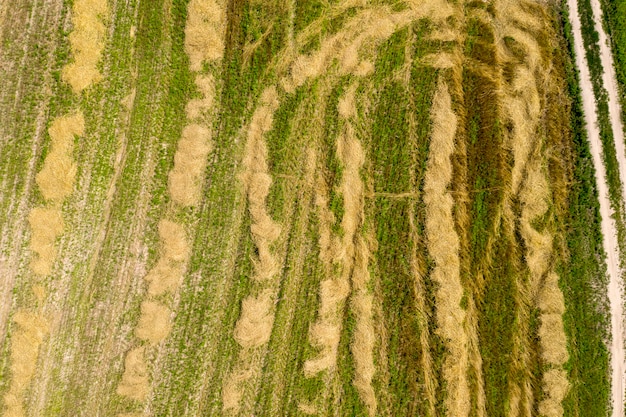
xmin=559 ymin=1 xmax=610 ymax=416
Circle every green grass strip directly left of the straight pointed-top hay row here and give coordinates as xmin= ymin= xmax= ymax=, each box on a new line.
xmin=368 ymin=24 xmax=436 ymax=415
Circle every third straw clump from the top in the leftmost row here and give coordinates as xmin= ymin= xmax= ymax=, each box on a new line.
xmin=28 ymin=207 xmax=64 ymax=276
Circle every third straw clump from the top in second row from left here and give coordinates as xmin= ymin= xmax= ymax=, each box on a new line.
xmin=168 ymin=124 xmax=213 ymax=207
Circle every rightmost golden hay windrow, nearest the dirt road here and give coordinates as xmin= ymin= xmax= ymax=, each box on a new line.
xmin=495 ymin=0 xmax=569 ymax=417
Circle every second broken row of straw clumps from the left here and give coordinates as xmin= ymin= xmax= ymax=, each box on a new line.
xmin=117 ymin=0 xmax=226 ymax=417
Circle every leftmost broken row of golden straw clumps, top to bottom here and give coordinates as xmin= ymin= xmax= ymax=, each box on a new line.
xmin=4 ymin=0 xmax=108 ymax=410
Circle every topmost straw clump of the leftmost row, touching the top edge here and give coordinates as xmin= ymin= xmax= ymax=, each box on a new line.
xmin=62 ymin=0 xmax=109 ymax=94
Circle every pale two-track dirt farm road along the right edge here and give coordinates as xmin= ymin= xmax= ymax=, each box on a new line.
xmin=567 ymin=0 xmax=626 ymax=417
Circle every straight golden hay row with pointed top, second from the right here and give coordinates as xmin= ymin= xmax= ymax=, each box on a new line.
xmin=424 ymin=80 xmax=470 ymax=416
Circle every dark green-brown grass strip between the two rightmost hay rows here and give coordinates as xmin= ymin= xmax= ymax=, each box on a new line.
xmin=455 ymin=8 xmax=514 ymax=415
